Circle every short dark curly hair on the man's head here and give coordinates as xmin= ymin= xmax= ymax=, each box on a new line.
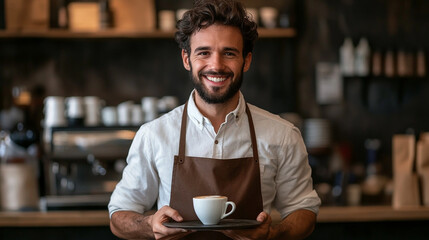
xmin=175 ymin=0 xmax=258 ymax=56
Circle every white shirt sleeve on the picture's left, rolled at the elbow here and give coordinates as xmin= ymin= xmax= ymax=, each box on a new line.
xmin=108 ymin=128 xmax=159 ymax=216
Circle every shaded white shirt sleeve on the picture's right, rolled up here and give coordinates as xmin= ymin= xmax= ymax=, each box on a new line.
xmin=274 ymin=127 xmax=321 ymax=218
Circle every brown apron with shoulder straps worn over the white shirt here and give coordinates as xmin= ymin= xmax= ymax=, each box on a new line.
xmin=170 ymin=103 xmax=263 ymax=239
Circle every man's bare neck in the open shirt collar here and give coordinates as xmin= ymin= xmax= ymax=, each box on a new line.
xmin=194 ymin=91 xmax=240 ymax=133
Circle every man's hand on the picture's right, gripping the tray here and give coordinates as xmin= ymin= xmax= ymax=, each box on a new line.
xmin=219 ymin=212 xmax=272 ymax=240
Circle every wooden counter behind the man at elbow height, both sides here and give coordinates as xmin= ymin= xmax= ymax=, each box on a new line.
xmin=0 ymin=206 xmax=429 ymax=227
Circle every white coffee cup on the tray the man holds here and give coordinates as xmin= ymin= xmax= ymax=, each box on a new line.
xmin=193 ymin=195 xmax=235 ymax=225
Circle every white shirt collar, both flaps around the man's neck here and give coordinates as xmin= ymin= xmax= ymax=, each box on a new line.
xmin=188 ymin=89 xmax=246 ymax=129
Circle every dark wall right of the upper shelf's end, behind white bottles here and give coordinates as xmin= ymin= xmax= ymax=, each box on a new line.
xmin=297 ymin=0 xmax=429 ymax=174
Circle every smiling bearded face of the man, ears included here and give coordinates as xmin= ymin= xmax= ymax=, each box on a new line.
xmin=182 ymin=24 xmax=251 ymax=103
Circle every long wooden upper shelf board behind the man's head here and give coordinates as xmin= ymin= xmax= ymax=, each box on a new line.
xmin=0 ymin=28 xmax=296 ymax=39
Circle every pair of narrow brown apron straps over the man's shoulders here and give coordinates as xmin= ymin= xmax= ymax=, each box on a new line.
xmin=179 ymin=102 xmax=259 ymax=163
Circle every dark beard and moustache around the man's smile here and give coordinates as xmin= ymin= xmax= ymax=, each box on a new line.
xmin=189 ymin=64 xmax=244 ymax=104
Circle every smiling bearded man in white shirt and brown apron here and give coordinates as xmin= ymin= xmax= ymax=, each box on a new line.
xmin=109 ymin=0 xmax=320 ymax=239
